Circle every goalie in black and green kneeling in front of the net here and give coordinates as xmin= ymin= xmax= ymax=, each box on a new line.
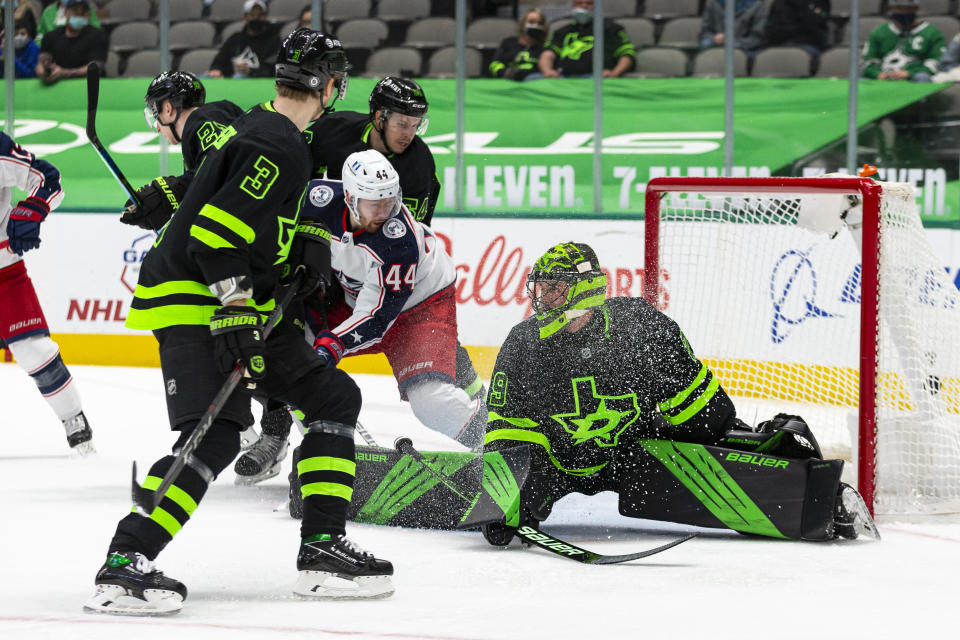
xmin=482 ymin=242 xmax=876 ymax=545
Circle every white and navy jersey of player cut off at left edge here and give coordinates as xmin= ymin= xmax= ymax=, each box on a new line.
xmin=0 ymin=131 xmax=63 ymax=269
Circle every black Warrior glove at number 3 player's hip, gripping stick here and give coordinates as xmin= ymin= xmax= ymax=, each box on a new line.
xmin=210 ymin=306 xmax=267 ymax=389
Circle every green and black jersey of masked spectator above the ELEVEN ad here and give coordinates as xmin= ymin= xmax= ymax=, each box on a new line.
xmin=544 ymin=20 xmax=636 ymax=76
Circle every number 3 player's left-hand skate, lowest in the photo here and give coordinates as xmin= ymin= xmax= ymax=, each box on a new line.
xmin=83 ymin=551 xmax=187 ymax=616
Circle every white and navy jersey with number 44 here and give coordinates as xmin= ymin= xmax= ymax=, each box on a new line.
xmin=302 ymin=180 xmax=457 ymax=354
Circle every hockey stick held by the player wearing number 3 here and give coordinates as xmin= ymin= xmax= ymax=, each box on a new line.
xmin=132 ymin=276 xmax=301 ymax=515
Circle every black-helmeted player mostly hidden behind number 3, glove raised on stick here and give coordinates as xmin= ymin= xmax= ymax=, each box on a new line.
xmin=120 ymin=71 xmax=243 ymax=231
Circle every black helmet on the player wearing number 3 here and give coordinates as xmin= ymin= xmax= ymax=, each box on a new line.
xmin=276 ymin=27 xmax=350 ymax=102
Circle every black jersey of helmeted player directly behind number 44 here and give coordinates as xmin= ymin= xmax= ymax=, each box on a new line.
xmin=304 ymin=111 xmax=440 ymax=225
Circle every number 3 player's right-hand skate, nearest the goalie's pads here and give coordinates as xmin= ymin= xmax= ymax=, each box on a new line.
xmin=293 ymin=534 xmax=393 ymax=599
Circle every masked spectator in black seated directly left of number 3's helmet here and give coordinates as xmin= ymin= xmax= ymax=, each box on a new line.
xmin=207 ymin=0 xmax=280 ymax=78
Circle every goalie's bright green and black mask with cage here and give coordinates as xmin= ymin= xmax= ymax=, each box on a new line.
xmin=527 ymin=242 xmax=607 ymax=340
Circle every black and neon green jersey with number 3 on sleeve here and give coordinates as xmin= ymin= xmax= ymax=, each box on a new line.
xmin=126 ymin=103 xmax=310 ymax=329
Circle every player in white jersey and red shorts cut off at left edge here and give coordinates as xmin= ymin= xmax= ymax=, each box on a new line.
xmin=0 ymin=132 xmax=93 ymax=455
